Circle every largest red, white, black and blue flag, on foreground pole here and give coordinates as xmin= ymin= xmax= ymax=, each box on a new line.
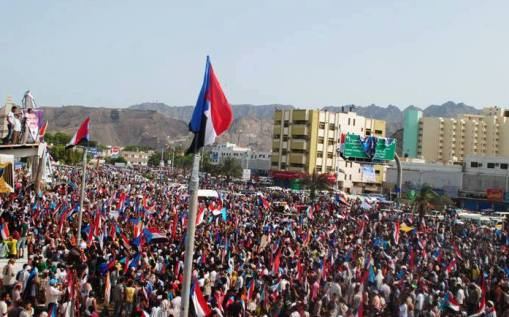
xmin=187 ymin=56 xmax=233 ymax=153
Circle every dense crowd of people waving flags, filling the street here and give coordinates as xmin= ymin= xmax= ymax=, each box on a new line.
xmin=0 ymin=166 xmax=509 ymax=317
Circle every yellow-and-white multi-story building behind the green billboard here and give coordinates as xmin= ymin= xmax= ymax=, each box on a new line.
xmin=271 ymin=109 xmax=385 ymax=192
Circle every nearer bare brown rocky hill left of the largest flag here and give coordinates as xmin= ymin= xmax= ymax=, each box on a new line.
xmin=44 ymin=106 xmax=189 ymax=148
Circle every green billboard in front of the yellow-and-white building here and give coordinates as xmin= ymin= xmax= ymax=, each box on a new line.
xmin=339 ymin=133 xmax=396 ymax=162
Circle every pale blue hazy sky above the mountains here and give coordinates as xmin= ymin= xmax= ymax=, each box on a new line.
xmin=0 ymin=0 xmax=509 ymax=107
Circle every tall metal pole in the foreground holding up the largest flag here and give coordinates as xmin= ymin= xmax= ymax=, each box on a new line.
xmin=180 ymin=151 xmax=200 ymax=317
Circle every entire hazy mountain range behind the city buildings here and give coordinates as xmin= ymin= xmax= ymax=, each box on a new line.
xmin=45 ymin=101 xmax=480 ymax=151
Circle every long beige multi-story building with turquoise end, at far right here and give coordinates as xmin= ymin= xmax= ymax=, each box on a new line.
xmin=403 ymin=107 xmax=509 ymax=163
